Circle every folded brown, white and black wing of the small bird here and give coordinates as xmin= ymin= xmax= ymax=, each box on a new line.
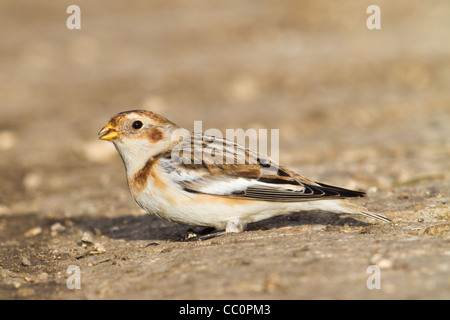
xmin=160 ymin=134 xmax=364 ymax=202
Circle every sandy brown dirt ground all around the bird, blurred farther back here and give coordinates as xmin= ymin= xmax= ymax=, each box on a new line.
xmin=0 ymin=0 xmax=450 ymax=299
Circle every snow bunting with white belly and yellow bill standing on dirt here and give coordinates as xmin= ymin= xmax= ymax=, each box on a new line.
xmin=99 ymin=110 xmax=390 ymax=238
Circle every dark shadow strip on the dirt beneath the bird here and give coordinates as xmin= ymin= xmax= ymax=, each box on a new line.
xmin=0 ymin=212 xmax=371 ymax=242
